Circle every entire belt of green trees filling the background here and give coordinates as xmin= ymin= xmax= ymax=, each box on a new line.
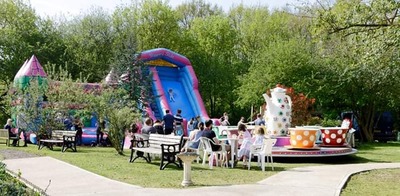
xmin=0 ymin=0 xmax=400 ymax=141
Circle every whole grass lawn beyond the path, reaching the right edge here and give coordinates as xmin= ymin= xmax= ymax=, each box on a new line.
xmin=0 ymin=143 xmax=400 ymax=191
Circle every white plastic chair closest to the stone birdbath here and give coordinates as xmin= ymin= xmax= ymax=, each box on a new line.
xmin=200 ymin=137 xmax=228 ymax=169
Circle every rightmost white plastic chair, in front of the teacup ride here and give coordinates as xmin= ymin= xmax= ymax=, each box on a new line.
xmin=247 ymin=138 xmax=276 ymax=171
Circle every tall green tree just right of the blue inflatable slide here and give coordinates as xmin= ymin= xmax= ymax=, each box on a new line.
xmin=187 ymin=16 xmax=245 ymax=116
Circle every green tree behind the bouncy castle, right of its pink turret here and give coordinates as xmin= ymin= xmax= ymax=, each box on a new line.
xmin=59 ymin=7 xmax=115 ymax=82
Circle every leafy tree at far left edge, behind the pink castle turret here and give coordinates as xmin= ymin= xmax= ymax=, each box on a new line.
xmin=0 ymin=0 xmax=64 ymax=122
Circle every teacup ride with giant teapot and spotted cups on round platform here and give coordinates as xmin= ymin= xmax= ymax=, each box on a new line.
xmin=263 ymin=86 xmax=357 ymax=157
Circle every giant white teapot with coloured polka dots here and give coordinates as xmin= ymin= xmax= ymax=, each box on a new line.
xmin=263 ymin=87 xmax=292 ymax=136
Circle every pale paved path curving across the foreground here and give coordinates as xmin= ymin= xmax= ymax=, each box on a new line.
xmin=3 ymin=157 xmax=400 ymax=196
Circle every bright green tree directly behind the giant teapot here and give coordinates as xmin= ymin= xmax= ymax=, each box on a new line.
xmin=236 ymin=10 xmax=319 ymax=106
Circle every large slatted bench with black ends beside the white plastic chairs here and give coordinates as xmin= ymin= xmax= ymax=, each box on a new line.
xmin=129 ymin=134 xmax=184 ymax=170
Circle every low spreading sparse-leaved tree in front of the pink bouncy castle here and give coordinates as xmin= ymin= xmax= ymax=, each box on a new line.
xmin=7 ymin=62 xmax=140 ymax=154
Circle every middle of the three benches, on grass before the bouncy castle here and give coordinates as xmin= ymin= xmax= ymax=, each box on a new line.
xmin=38 ymin=130 xmax=76 ymax=152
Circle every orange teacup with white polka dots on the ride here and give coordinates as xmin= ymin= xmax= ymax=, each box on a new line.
xmin=289 ymin=127 xmax=318 ymax=148
